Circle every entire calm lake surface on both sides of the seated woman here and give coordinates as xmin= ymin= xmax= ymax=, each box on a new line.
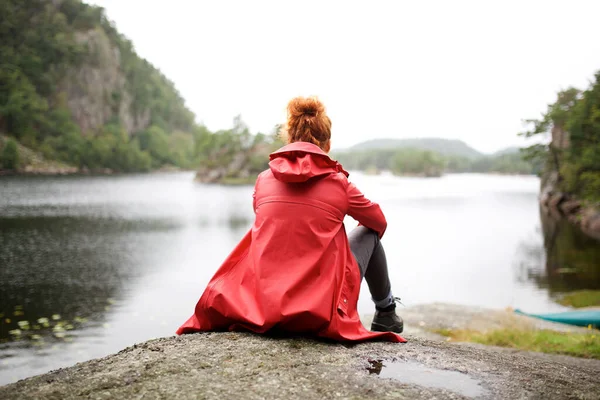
xmin=0 ymin=173 xmax=600 ymax=384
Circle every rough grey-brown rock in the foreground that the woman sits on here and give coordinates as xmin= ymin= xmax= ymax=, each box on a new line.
xmin=0 ymin=333 xmax=600 ymax=399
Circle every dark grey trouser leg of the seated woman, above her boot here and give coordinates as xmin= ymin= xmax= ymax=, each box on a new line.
xmin=348 ymin=226 xmax=394 ymax=309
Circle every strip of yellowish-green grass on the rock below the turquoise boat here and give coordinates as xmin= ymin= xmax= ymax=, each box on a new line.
xmin=435 ymin=329 xmax=600 ymax=359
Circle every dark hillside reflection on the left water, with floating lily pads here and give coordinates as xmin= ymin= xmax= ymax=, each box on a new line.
xmin=0 ymin=216 xmax=178 ymax=344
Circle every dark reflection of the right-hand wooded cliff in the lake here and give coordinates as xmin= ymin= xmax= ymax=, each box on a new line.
xmin=517 ymin=210 xmax=600 ymax=294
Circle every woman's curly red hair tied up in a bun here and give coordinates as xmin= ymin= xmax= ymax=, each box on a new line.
xmin=282 ymin=97 xmax=331 ymax=152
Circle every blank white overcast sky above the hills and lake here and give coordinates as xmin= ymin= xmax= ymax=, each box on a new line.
xmin=89 ymin=0 xmax=600 ymax=152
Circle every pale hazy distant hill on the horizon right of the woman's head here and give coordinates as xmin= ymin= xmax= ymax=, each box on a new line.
xmin=346 ymin=138 xmax=483 ymax=158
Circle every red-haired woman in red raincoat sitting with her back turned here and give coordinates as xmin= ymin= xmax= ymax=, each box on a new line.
xmin=177 ymin=97 xmax=405 ymax=342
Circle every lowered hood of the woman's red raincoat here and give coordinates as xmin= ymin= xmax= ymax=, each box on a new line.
xmin=269 ymin=142 xmax=349 ymax=183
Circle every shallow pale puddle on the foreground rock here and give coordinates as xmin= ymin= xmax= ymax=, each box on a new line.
xmin=367 ymin=360 xmax=484 ymax=397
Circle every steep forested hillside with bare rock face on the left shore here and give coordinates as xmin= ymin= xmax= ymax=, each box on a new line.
xmin=0 ymin=0 xmax=273 ymax=172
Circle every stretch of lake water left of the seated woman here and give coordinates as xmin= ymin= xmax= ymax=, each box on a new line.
xmin=0 ymin=173 xmax=252 ymax=385
